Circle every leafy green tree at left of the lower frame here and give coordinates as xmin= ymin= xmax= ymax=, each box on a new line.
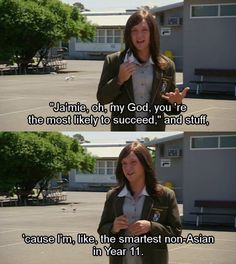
xmin=0 ymin=132 xmax=95 ymax=202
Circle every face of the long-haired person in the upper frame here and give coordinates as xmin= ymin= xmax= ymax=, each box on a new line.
xmin=131 ymin=19 xmax=150 ymax=52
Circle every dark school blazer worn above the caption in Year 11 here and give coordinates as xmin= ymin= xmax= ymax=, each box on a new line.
xmin=97 ymin=185 xmax=182 ymax=264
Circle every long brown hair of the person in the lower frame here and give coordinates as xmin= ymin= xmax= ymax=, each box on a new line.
xmin=116 ymin=141 xmax=158 ymax=196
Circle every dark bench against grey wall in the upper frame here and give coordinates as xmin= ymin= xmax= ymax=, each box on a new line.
xmin=189 ymin=69 xmax=236 ymax=96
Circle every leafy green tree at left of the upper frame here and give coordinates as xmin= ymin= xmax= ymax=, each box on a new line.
xmin=0 ymin=0 xmax=95 ymax=68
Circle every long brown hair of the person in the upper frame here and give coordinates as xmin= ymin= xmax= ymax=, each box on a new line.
xmin=124 ymin=9 xmax=167 ymax=69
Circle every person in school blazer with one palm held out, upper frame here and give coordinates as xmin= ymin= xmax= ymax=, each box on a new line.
xmin=97 ymin=10 xmax=189 ymax=131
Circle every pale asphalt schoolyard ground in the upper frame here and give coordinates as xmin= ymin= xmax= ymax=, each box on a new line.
xmin=0 ymin=60 xmax=236 ymax=132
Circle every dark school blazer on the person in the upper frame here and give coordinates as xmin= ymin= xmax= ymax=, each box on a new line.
xmin=97 ymin=52 xmax=180 ymax=131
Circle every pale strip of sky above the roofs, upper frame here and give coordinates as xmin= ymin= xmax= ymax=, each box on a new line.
xmin=61 ymin=0 xmax=181 ymax=11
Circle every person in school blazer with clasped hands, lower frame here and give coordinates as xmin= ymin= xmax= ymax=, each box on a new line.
xmin=98 ymin=142 xmax=181 ymax=264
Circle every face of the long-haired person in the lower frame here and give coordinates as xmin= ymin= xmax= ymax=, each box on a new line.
xmin=121 ymin=151 xmax=145 ymax=185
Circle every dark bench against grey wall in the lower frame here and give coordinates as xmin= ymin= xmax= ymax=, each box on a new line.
xmin=190 ymin=200 xmax=236 ymax=228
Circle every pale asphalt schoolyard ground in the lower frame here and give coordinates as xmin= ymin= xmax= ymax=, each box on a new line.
xmin=0 ymin=192 xmax=236 ymax=264
